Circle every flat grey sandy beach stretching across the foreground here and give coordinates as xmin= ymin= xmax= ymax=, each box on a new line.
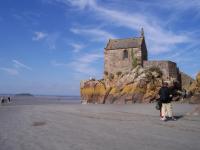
xmin=0 ymin=98 xmax=200 ymax=150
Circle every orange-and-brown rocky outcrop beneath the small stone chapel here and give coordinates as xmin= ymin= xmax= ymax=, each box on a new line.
xmin=80 ymin=66 xmax=172 ymax=104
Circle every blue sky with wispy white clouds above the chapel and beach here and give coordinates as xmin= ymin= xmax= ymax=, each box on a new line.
xmin=0 ymin=0 xmax=200 ymax=95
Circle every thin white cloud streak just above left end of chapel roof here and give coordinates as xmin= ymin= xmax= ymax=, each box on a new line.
xmin=70 ymin=28 xmax=116 ymax=41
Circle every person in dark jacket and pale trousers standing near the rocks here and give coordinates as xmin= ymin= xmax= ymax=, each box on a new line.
xmin=159 ymin=82 xmax=176 ymax=121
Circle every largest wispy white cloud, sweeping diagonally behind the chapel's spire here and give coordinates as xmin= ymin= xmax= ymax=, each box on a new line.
xmin=95 ymin=2 xmax=188 ymax=53
